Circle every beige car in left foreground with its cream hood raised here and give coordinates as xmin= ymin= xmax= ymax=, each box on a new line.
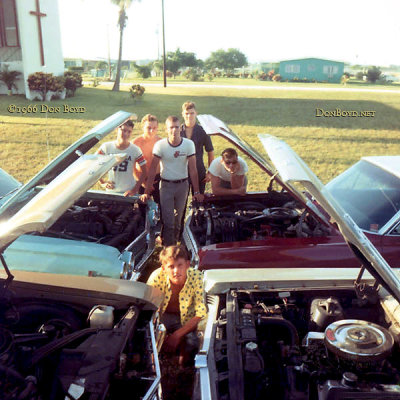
xmin=0 ymin=130 xmax=163 ymax=400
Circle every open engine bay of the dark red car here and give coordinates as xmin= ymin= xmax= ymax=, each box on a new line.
xmin=189 ymin=192 xmax=330 ymax=246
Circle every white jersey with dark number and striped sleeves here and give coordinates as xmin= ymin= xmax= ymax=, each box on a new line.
xmin=98 ymin=142 xmax=146 ymax=193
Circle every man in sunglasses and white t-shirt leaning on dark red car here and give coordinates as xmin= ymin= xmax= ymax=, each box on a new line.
xmin=208 ymin=148 xmax=248 ymax=196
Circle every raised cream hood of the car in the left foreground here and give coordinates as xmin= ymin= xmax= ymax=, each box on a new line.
xmin=0 ymin=154 xmax=126 ymax=253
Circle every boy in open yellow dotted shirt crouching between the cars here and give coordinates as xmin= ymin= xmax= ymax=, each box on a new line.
xmin=147 ymin=246 xmax=207 ymax=364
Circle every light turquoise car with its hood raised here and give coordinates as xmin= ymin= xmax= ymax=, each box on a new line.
xmin=0 ymin=111 xmax=158 ymax=280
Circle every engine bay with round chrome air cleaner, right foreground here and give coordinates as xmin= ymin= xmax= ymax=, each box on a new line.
xmin=213 ymin=290 xmax=400 ymax=400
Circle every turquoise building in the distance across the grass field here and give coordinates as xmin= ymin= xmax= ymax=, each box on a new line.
xmin=279 ymin=58 xmax=344 ymax=83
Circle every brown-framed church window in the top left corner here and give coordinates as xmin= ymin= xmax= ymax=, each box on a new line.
xmin=0 ymin=0 xmax=19 ymax=47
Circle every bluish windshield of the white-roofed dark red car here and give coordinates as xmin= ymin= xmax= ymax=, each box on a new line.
xmin=327 ymin=160 xmax=400 ymax=232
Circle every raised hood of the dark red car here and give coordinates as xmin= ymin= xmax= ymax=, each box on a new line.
xmin=197 ymin=114 xmax=327 ymax=223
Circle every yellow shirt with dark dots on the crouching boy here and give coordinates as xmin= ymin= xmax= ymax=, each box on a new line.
xmin=147 ymin=268 xmax=207 ymax=326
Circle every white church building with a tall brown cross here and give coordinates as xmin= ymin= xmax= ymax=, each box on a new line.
xmin=0 ymin=0 xmax=64 ymax=98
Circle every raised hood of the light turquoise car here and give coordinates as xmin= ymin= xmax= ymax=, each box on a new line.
xmin=0 ymin=111 xmax=136 ymax=214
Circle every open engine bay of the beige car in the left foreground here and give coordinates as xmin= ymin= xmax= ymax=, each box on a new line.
xmin=0 ymin=290 xmax=159 ymax=400
